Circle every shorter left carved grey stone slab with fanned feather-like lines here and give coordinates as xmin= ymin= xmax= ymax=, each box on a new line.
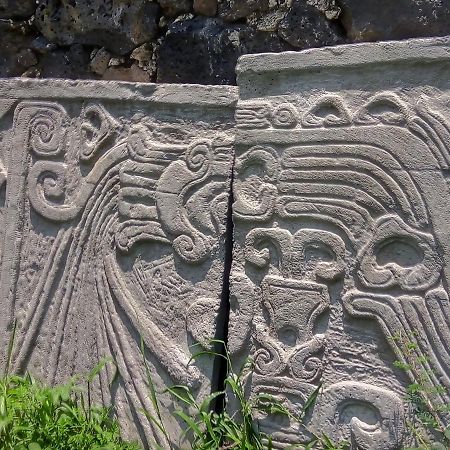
xmin=0 ymin=80 xmax=239 ymax=448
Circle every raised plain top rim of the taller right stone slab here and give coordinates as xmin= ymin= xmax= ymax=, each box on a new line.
xmin=236 ymin=36 xmax=450 ymax=77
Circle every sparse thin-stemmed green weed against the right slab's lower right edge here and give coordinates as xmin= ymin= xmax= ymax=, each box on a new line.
xmin=391 ymin=333 xmax=450 ymax=450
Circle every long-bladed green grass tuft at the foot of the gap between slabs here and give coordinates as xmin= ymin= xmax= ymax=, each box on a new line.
xmin=144 ymin=340 xmax=348 ymax=450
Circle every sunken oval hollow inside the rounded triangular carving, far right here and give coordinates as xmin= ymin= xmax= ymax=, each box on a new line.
xmin=375 ymin=237 xmax=424 ymax=267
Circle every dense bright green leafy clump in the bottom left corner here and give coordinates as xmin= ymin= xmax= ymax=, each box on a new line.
xmin=0 ymin=374 xmax=139 ymax=450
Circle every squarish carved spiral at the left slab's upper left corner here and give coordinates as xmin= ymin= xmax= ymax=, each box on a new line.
xmin=29 ymin=108 xmax=65 ymax=156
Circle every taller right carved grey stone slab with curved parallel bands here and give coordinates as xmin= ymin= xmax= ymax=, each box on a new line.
xmin=229 ymin=38 xmax=450 ymax=450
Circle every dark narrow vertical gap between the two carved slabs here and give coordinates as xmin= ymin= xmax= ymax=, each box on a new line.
xmin=211 ymin=149 xmax=235 ymax=413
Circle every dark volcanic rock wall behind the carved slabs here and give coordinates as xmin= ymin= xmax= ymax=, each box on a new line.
xmin=0 ymin=0 xmax=450 ymax=84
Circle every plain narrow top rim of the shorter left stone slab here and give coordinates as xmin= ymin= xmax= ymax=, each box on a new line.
xmin=0 ymin=78 xmax=238 ymax=107
